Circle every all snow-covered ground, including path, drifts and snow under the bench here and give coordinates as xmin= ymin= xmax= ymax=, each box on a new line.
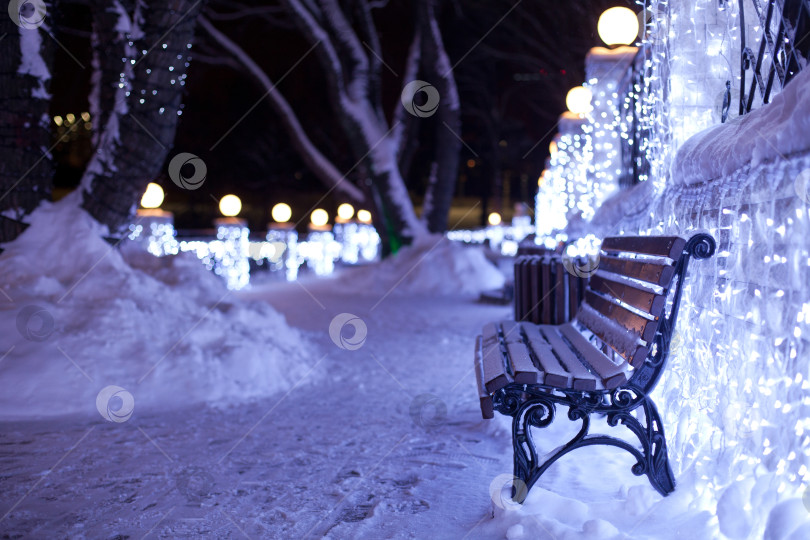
xmin=0 ymin=199 xmax=810 ymax=540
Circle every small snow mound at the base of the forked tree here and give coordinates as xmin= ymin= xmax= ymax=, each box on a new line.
xmin=337 ymin=235 xmax=505 ymax=295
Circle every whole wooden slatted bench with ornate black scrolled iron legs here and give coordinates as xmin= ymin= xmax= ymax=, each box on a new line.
xmin=475 ymin=234 xmax=715 ymax=503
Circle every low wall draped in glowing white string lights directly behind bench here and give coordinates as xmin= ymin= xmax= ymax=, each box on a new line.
xmin=614 ymin=146 xmax=810 ymax=539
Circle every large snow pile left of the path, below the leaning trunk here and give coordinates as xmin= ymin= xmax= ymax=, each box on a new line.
xmin=0 ymin=196 xmax=317 ymax=419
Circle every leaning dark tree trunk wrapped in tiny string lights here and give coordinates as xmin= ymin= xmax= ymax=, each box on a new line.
xmin=82 ymin=0 xmax=201 ymax=235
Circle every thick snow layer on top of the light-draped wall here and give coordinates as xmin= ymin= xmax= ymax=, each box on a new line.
xmin=672 ymin=65 xmax=810 ymax=185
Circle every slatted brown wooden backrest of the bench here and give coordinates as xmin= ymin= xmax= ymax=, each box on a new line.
xmin=577 ymin=234 xmax=715 ymax=383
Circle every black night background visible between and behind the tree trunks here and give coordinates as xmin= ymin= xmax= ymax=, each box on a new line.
xmin=51 ymin=0 xmax=625 ymax=229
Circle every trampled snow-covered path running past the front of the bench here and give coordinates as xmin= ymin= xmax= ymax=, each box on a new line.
xmin=0 ymin=284 xmax=511 ymax=538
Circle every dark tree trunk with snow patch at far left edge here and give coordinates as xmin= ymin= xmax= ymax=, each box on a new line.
xmin=0 ymin=10 xmax=53 ymax=244
